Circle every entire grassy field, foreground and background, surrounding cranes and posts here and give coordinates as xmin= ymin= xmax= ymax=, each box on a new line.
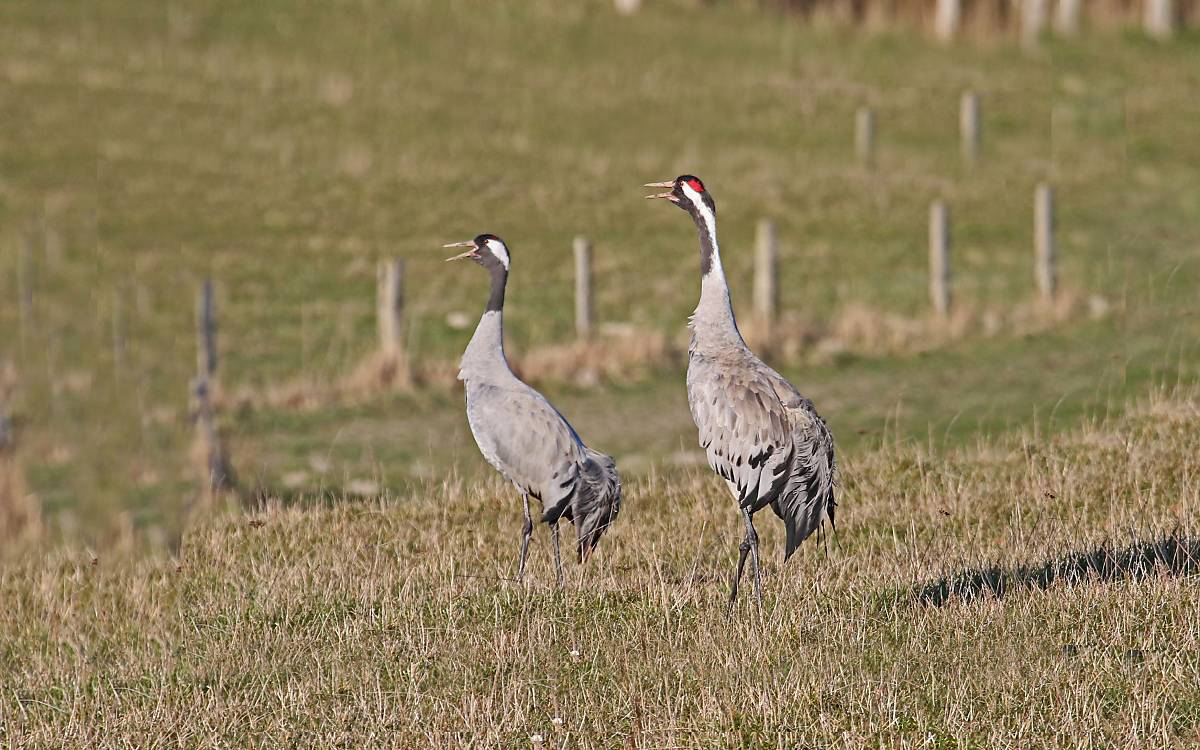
xmin=0 ymin=0 xmax=1200 ymax=748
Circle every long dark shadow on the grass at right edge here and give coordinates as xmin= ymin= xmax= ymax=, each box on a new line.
xmin=914 ymin=532 xmax=1200 ymax=607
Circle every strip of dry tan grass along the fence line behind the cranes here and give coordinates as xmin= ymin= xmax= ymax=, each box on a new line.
xmin=225 ymin=289 xmax=1109 ymax=412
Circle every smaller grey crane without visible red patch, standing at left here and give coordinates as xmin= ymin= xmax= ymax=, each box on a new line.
xmin=445 ymin=234 xmax=620 ymax=586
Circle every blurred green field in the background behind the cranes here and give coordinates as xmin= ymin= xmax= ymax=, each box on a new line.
xmin=0 ymin=0 xmax=1200 ymax=535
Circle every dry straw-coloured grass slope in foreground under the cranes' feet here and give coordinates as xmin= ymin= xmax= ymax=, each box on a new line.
xmin=0 ymin=392 xmax=1200 ymax=748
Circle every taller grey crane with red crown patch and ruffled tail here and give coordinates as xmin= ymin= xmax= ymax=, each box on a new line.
xmin=646 ymin=174 xmax=838 ymax=610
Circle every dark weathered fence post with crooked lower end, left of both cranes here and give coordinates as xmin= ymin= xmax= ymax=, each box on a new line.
xmin=192 ymin=278 xmax=234 ymax=502
